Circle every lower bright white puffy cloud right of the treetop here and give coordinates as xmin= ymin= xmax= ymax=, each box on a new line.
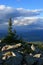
xmin=13 ymin=17 xmax=43 ymax=26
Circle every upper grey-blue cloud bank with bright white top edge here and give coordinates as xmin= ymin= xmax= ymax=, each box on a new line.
xmin=0 ymin=5 xmax=43 ymax=24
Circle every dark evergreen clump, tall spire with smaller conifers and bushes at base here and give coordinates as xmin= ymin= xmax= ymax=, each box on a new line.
xmin=1 ymin=18 xmax=23 ymax=44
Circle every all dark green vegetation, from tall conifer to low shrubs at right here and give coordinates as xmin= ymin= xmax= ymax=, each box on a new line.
xmin=1 ymin=18 xmax=43 ymax=54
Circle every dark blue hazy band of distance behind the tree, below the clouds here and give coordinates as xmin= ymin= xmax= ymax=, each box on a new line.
xmin=0 ymin=29 xmax=43 ymax=41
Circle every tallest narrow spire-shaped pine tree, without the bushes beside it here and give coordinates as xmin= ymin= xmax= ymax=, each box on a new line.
xmin=7 ymin=18 xmax=14 ymax=43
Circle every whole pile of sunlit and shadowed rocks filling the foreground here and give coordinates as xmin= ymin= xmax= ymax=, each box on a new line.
xmin=0 ymin=43 xmax=43 ymax=65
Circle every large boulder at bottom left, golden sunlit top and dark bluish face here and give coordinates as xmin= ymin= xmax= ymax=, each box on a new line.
xmin=0 ymin=52 xmax=23 ymax=65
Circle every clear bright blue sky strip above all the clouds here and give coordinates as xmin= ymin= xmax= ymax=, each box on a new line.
xmin=0 ymin=0 xmax=43 ymax=9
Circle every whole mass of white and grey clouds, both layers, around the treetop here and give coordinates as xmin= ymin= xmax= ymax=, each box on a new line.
xmin=0 ymin=5 xmax=43 ymax=26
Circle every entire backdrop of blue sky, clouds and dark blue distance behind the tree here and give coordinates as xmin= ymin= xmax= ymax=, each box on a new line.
xmin=0 ymin=0 xmax=43 ymax=40
